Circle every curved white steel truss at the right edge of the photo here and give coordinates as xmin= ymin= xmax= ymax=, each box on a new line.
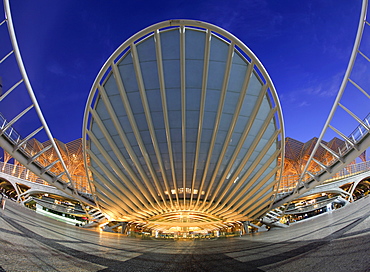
xmin=273 ymin=0 xmax=370 ymax=208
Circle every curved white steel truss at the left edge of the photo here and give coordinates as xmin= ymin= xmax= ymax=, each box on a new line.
xmin=0 ymin=0 xmax=94 ymax=205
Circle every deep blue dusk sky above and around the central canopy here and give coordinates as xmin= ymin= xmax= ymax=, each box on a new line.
xmin=0 ymin=0 xmax=369 ymax=142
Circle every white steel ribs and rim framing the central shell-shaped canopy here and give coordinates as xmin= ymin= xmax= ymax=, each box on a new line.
xmin=83 ymin=20 xmax=285 ymax=227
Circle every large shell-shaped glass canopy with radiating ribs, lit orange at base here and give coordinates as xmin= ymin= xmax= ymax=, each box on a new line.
xmin=83 ymin=20 xmax=284 ymax=231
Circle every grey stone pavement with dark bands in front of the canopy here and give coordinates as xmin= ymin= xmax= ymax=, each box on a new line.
xmin=0 ymin=197 xmax=370 ymax=272
